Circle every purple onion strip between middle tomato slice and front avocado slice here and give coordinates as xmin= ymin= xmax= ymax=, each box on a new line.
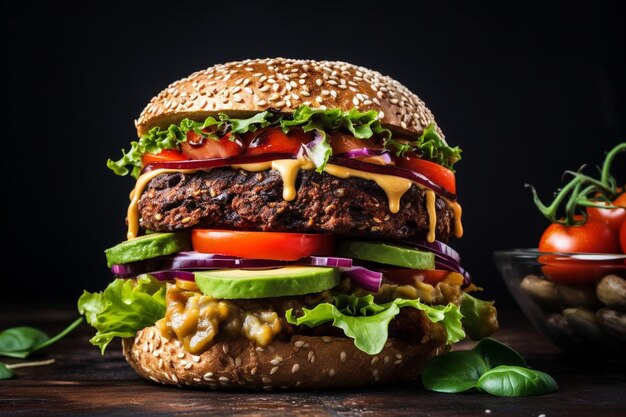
xmin=111 ymin=251 xmax=352 ymax=278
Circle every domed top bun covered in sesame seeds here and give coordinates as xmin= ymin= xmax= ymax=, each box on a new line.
xmin=135 ymin=58 xmax=443 ymax=137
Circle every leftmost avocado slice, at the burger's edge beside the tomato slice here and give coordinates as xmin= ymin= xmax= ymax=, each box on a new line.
xmin=104 ymin=232 xmax=191 ymax=268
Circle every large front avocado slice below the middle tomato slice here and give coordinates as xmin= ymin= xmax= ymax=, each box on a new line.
xmin=194 ymin=266 xmax=339 ymax=299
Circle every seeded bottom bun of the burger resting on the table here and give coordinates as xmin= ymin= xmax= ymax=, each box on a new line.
xmin=122 ymin=326 xmax=448 ymax=390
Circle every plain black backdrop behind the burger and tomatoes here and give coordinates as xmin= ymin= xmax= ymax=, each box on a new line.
xmin=0 ymin=1 xmax=626 ymax=305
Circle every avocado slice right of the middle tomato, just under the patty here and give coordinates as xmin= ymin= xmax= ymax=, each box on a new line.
xmin=336 ymin=240 xmax=435 ymax=269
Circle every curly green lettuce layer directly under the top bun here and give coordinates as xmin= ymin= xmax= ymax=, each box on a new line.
xmin=107 ymin=105 xmax=461 ymax=178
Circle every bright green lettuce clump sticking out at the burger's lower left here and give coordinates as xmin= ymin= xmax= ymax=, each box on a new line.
xmin=78 ymin=275 xmax=165 ymax=354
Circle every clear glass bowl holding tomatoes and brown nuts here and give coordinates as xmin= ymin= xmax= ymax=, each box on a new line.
xmin=494 ymin=249 xmax=626 ymax=358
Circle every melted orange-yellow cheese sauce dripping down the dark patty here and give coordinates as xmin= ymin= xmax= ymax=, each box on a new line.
xmin=126 ymin=158 xmax=463 ymax=242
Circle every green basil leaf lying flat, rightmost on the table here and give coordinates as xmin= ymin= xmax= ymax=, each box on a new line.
xmin=477 ymin=365 xmax=559 ymax=397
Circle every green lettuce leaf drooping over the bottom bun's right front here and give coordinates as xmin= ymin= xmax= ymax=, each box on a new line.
xmin=285 ymin=294 xmax=465 ymax=355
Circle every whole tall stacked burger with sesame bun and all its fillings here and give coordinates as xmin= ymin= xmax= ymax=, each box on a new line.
xmin=78 ymin=58 xmax=497 ymax=390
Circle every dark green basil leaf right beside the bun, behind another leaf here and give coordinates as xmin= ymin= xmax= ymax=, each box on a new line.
xmin=422 ymin=351 xmax=489 ymax=393
